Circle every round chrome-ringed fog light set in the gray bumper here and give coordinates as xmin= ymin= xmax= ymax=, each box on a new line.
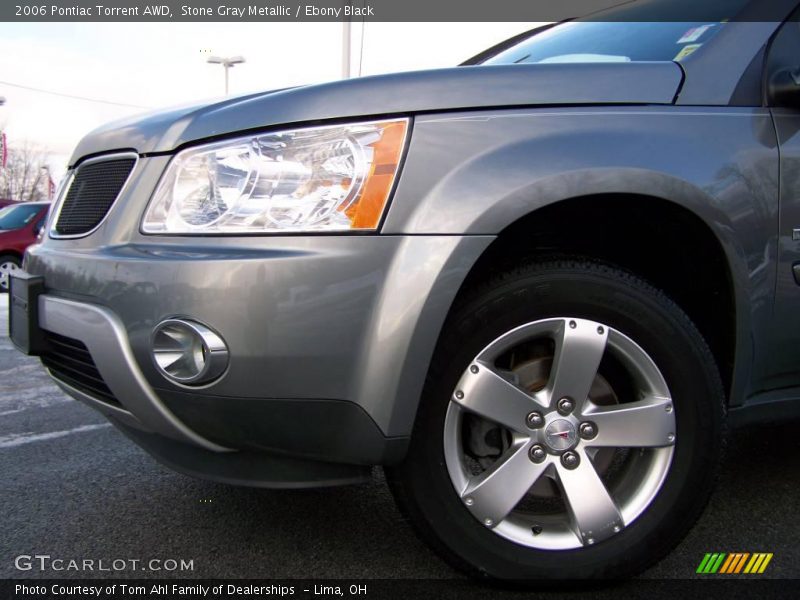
xmin=153 ymin=319 xmax=228 ymax=385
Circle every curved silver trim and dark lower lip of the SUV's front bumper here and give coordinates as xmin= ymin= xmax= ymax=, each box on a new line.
xmin=33 ymin=295 xmax=370 ymax=488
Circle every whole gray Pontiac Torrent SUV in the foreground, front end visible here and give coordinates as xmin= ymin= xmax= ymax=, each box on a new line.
xmin=11 ymin=0 xmax=800 ymax=580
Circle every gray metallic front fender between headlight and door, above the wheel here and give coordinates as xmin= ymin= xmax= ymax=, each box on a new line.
xmin=383 ymin=107 xmax=778 ymax=412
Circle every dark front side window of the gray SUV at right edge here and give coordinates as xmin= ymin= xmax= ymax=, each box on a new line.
xmin=765 ymin=10 xmax=800 ymax=108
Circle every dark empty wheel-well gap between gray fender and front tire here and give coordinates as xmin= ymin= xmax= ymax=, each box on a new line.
xmin=451 ymin=192 xmax=752 ymax=404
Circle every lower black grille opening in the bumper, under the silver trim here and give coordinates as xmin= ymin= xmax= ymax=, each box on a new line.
xmin=42 ymin=331 xmax=120 ymax=406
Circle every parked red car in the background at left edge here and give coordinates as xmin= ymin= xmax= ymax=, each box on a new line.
xmin=0 ymin=202 xmax=50 ymax=293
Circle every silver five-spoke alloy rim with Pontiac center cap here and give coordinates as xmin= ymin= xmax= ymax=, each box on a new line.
xmin=444 ymin=317 xmax=676 ymax=550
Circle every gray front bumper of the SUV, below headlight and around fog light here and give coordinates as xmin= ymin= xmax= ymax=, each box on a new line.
xmin=25 ymin=236 xmax=491 ymax=487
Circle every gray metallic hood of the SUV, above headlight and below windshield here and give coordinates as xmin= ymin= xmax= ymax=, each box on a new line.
xmin=70 ymin=62 xmax=683 ymax=165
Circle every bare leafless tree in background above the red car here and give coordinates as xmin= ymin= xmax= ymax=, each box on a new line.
xmin=0 ymin=137 xmax=49 ymax=202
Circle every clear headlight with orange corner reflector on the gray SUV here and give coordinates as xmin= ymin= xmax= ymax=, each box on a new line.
xmin=142 ymin=119 xmax=408 ymax=234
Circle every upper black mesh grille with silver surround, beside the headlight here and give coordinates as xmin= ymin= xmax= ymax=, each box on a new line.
xmin=55 ymin=158 xmax=136 ymax=235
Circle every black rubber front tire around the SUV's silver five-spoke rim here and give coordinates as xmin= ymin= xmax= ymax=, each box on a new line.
xmin=387 ymin=258 xmax=725 ymax=581
